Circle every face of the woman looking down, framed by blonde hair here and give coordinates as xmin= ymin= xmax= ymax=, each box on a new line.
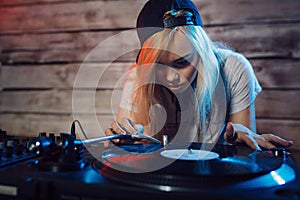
xmin=156 ymin=31 xmax=199 ymax=93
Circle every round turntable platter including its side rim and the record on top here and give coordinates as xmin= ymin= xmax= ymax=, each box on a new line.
xmin=92 ymin=143 xmax=296 ymax=191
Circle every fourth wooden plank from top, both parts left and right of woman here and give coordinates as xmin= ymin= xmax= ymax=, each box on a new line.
xmin=0 ymin=89 xmax=300 ymax=119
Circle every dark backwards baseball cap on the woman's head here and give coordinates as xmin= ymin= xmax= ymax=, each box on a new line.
xmin=136 ymin=0 xmax=203 ymax=44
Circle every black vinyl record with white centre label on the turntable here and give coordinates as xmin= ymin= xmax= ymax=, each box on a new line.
xmin=100 ymin=143 xmax=283 ymax=176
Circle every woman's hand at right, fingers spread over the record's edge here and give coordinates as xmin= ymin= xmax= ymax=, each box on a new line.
xmin=224 ymin=122 xmax=293 ymax=150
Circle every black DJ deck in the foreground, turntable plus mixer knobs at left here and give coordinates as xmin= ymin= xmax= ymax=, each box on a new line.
xmin=0 ymin=129 xmax=300 ymax=199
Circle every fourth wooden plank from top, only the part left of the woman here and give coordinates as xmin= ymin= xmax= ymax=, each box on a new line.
xmin=0 ymin=90 xmax=121 ymax=114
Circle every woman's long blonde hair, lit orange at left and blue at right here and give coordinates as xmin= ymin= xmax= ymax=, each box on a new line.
xmin=132 ymin=25 xmax=227 ymax=140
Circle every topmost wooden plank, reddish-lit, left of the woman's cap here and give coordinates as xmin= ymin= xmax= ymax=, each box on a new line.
xmin=0 ymin=0 xmax=145 ymax=33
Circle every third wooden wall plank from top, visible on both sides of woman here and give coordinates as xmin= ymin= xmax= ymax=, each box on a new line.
xmin=0 ymin=59 xmax=300 ymax=90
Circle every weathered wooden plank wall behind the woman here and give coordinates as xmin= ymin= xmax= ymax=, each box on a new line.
xmin=0 ymin=0 xmax=300 ymax=148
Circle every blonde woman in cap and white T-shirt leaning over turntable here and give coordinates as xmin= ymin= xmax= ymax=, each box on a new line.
xmin=106 ymin=0 xmax=292 ymax=150
